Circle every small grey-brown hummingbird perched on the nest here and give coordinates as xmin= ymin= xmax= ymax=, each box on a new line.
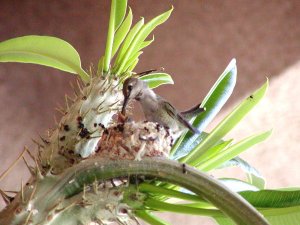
xmin=121 ymin=77 xmax=205 ymax=134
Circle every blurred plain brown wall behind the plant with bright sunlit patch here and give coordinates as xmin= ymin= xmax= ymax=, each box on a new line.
xmin=0 ymin=0 xmax=300 ymax=224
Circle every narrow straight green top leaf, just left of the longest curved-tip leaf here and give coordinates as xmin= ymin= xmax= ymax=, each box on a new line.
xmin=113 ymin=18 xmax=144 ymax=69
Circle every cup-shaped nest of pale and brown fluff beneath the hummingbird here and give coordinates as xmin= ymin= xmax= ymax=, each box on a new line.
xmin=96 ymin=121 xmax=173 ymax=160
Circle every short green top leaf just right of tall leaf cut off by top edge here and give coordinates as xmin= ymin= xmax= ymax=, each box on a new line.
xmin=111 ymin=8 xmax=132 ymax=58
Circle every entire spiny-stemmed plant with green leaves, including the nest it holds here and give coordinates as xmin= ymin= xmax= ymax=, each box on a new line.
xmin=0 ymin=0 xmax=300 ymax=225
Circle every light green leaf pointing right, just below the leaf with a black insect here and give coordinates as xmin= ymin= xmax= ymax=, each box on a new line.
xmin=197 ymin=131 xmax=272 ymax=171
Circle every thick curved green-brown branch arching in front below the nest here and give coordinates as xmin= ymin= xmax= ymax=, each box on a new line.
xmin=0 ymin=158 xmax=269 ymax=225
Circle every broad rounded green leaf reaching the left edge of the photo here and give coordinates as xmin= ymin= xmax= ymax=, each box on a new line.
xmin=0 ymin=35 xmax=89 ymax=81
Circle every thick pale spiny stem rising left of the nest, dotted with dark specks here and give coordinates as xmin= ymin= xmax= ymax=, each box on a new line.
xmin=39 ymin=76 xmax=123 ymax=174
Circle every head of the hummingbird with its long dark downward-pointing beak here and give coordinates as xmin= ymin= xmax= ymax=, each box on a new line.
xmin=122 ymin=77 xmax=147 ymax=115
